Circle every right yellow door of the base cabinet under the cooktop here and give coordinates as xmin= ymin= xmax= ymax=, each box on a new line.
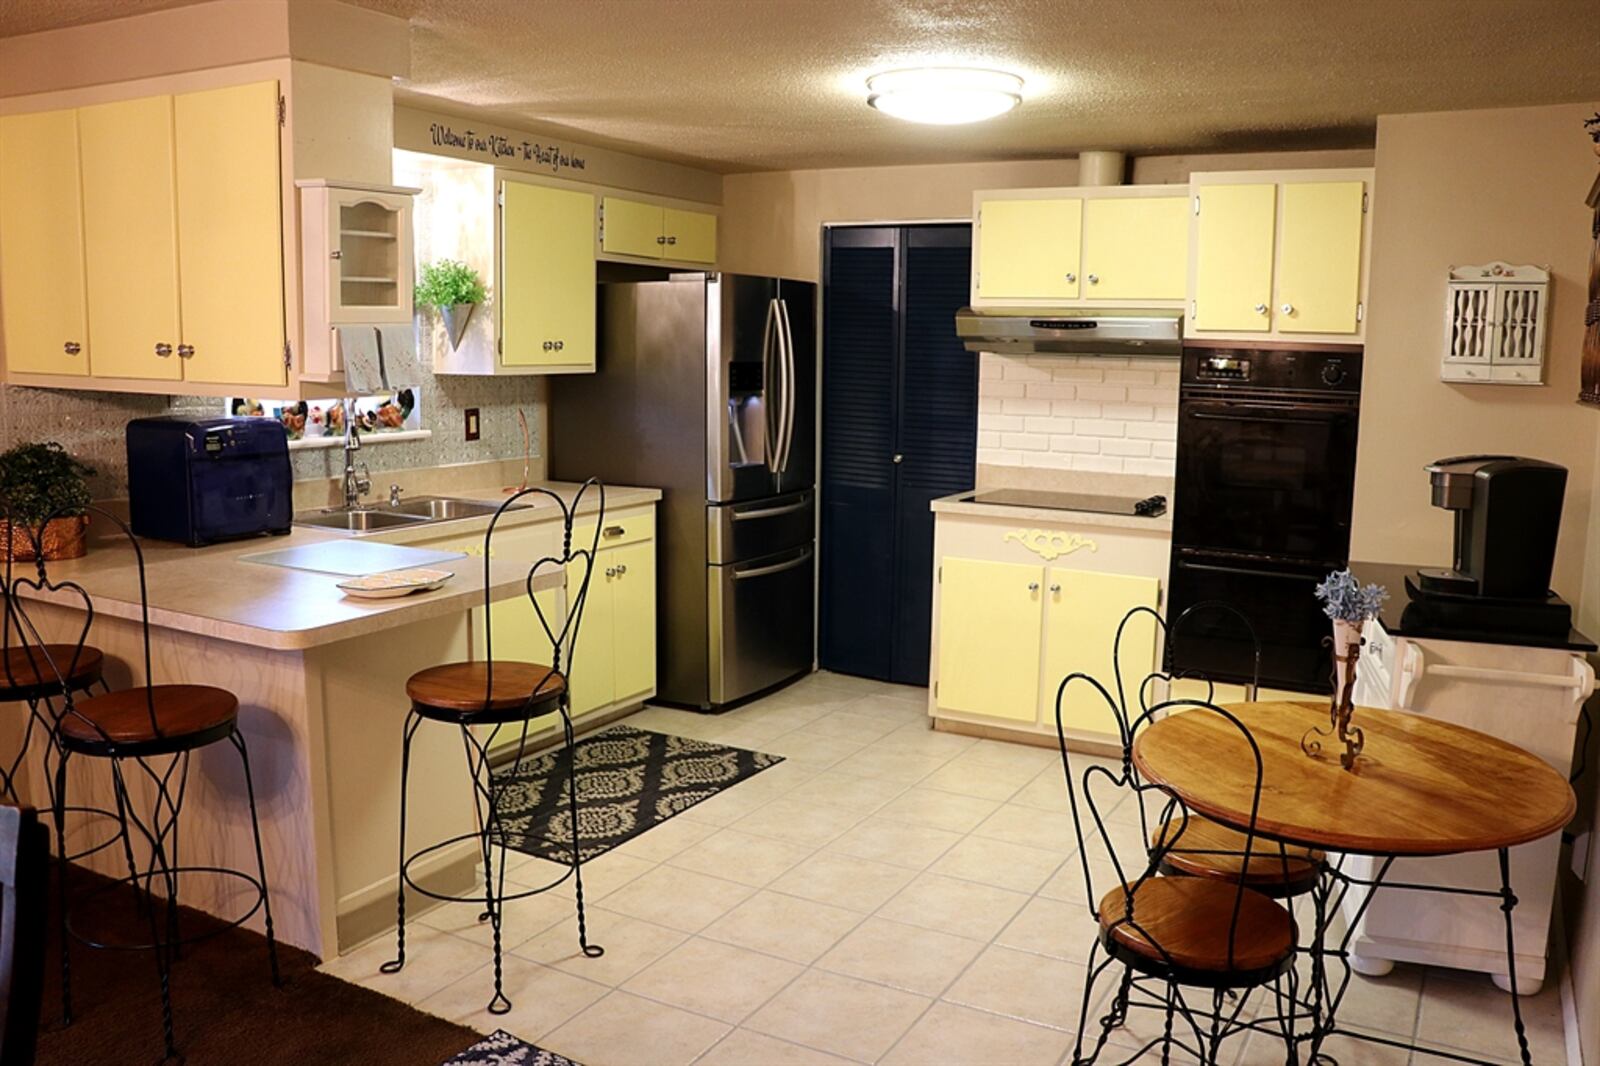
xmin=1045 ymin=567 xmax=1160 ymax=738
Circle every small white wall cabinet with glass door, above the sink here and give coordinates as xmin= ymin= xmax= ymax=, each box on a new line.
xmin=294 ymin=179 xmax=419 ymax=379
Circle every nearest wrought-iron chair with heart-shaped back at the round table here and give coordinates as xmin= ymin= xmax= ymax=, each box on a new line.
xmin=1056 ymin=674 xmax=1298 ymax=1066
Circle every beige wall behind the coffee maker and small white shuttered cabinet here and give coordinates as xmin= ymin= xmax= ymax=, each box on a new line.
xmin=1350 ymin=104 xmax=1600 ymax=600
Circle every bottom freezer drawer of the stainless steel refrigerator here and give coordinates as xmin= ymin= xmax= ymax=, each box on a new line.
xmin=707 ymin=543 xmax=816 ymax=706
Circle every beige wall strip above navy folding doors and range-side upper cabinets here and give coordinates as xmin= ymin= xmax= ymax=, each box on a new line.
xmin=720 ymin=149 xmax=1373 ymax=280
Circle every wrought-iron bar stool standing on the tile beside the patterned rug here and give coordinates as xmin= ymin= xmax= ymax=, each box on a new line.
xmin=379 ymin=479 xmax=605 ymax=1015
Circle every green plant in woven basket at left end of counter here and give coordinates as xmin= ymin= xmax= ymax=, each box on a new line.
xmin=0 ymin=440 xmax=94 ymax=560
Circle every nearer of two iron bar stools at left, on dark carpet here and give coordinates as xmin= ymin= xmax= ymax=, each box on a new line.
xmin=10 ymin=507 xmax=282 ymax=1061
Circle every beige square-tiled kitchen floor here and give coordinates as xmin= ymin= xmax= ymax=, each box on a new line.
xmin=326 ymin=674 xmax=1566 ymax=1066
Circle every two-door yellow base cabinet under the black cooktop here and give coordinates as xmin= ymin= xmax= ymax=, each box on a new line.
xmin=928 ymin=506 xmax=1171 ymax=749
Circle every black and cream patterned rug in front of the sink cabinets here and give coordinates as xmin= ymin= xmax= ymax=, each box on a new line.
xmin=496 ymin=725 xmax=782 ymax=863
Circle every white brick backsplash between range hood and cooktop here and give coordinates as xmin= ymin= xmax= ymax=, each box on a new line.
xmin=978 ymin=352 xmax=1178 ymax=477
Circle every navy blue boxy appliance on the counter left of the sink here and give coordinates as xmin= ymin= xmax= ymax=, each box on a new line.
xmin=126 ymin=418 xmax=294 ymax=547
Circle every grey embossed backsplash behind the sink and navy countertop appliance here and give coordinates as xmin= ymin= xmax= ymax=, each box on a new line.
xmin=0 ymin=348 xmax=546 ymax=499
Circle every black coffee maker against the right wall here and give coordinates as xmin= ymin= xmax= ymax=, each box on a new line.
xmin=1406 ymin=455 xmax=1571 ymax=632
